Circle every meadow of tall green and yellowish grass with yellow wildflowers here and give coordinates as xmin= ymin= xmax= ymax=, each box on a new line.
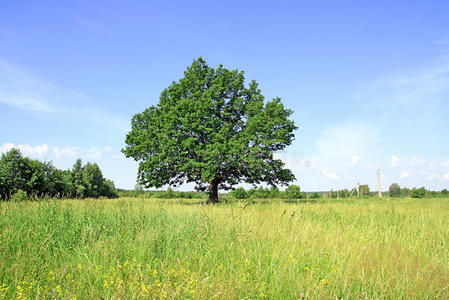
xmin=0 ymin=198 xmax=449 ymax=299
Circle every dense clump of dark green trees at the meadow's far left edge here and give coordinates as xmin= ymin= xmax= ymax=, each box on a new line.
xmin=0 ymin=149 xmax=118 ymax=200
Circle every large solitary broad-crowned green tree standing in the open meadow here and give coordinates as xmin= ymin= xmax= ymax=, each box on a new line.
xmin=122 ymin=58 xmax=296 ymax=202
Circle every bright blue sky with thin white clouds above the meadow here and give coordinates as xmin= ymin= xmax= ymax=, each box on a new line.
xmin=0 ymin=1 xmax=449 ymax=191
